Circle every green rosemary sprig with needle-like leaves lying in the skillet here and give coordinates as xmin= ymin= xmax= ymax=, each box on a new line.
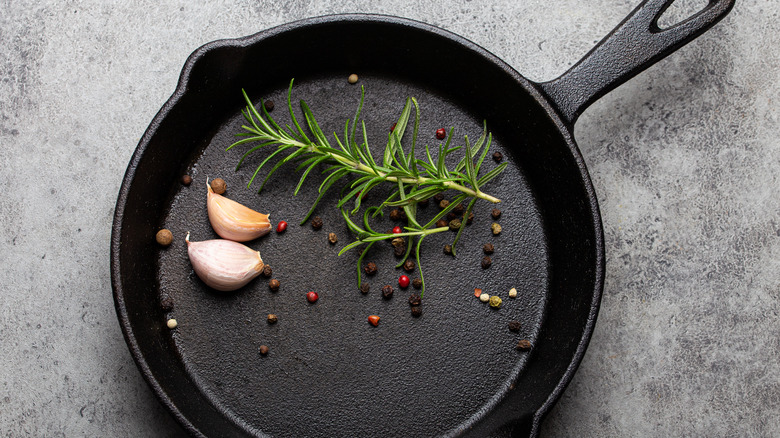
xmin=227 ymin=80 xmax=507 ymax=291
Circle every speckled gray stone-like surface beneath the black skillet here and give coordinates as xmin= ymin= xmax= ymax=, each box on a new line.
xmin=0 ymin=0 xmax=780 ymax=437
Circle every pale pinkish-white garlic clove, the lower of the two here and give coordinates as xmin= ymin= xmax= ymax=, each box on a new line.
xmin=184 ymin=233 xmax=264 ymax=292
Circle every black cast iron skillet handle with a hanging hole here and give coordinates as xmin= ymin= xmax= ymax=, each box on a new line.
xmin=539 ymin=0 xmax=735 ymax=128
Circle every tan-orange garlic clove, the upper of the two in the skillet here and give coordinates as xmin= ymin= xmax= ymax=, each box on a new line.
xmin=206 ymin=181 xmax=271 ymax=242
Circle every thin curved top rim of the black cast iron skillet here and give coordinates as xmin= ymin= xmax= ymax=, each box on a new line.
xmin=110 ymin=13 xmax=605 ymax=436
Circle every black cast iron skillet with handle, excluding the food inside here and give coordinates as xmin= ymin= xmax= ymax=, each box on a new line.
xmin=111 ymin=0 xmax=734 ymax=437
